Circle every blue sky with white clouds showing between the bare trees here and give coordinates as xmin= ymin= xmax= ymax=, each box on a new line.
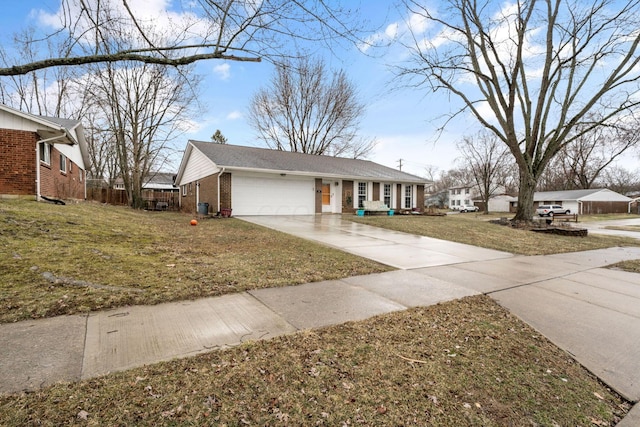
xmin=0 ymin=0 xmax=633 ymax=176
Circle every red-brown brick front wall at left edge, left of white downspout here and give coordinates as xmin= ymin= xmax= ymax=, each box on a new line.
xmin=0 ymin=129 xmax=37 ymax=196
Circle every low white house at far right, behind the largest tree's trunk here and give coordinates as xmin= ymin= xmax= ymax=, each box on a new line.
xmin=511 ymin=188 xmax=632 ymax=215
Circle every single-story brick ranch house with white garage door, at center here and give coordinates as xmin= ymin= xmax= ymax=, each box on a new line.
xmin=176 ymin=141 xmax=426 ymax=215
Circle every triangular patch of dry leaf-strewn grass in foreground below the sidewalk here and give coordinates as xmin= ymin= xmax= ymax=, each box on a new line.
xmin=0 ymin=296 xmax=629 ymax=426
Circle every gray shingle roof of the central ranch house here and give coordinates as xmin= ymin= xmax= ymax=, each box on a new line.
xmin=189 ymin=141 xmax=427 ymax=183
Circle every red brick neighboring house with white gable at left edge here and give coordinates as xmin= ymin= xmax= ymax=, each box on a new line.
xmin=0 ymin=104 xmax=89 ymax=200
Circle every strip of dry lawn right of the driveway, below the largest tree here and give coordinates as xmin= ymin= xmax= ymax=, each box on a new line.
xmin=347 ymin=214 xmax=640 ymax=255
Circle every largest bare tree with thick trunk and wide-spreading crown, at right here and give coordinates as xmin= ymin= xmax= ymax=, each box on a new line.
xmin=400 ymin=0 xmax=640 ymax=221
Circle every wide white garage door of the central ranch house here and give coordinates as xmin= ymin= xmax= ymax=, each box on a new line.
xmin=231 ymin=174 xmax=315 ymax=215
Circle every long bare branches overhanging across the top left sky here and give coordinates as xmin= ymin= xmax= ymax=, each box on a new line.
xmin=0 ymin=0 xmax=362 ymax=76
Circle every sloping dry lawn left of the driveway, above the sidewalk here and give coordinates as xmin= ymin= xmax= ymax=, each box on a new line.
xmin=0 ymin=201 xmax=390 ymax=322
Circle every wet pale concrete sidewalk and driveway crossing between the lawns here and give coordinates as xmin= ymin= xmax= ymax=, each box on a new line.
xmin=0 ymin=219 xmax=640 ymax=426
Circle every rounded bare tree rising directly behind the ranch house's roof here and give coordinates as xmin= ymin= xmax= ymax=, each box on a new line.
xmin=249 ymin=57 xmax=374 ymax=158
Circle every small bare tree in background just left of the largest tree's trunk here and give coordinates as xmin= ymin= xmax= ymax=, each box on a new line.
xmin=458 ymin=131 xmax=513 ymax=214
